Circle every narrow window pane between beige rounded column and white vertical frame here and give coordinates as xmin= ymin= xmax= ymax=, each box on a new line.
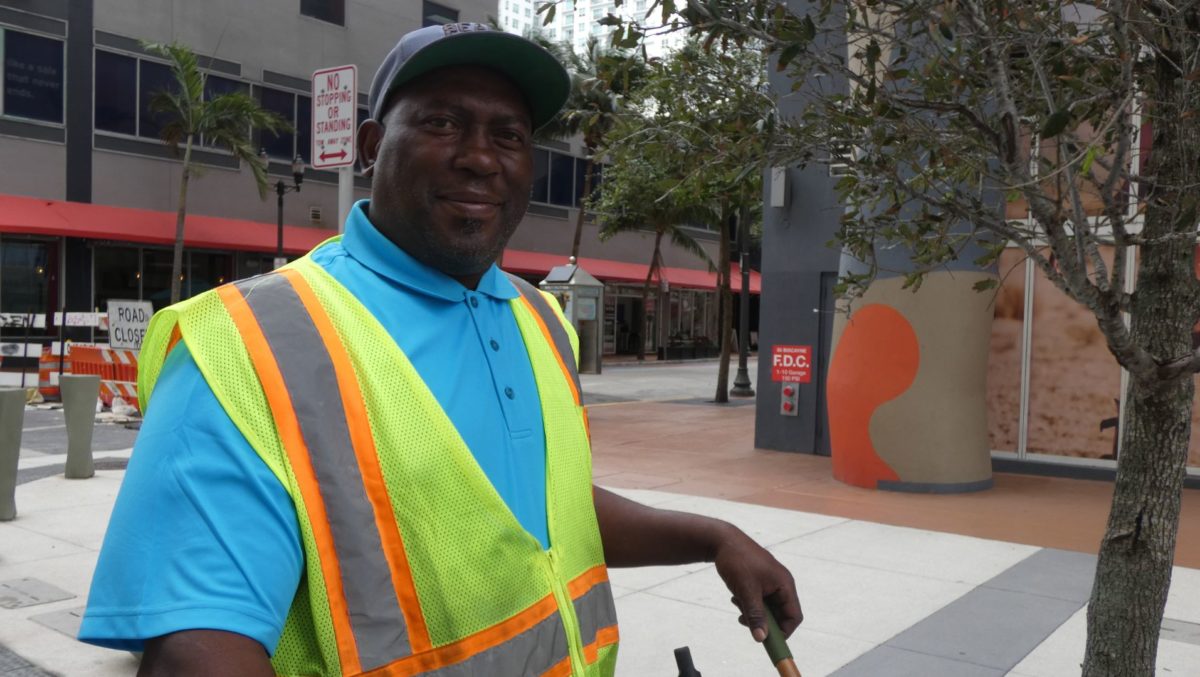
xmin=988 ymin=247 xmax=1025 ymax=451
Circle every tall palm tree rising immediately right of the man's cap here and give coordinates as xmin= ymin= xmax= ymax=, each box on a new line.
xmin=529 ymin=32 xmax=646 ymax=258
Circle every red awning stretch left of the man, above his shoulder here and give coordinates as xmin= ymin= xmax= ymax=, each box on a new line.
xmin=0 ymin=194 xmax=337 ymax=254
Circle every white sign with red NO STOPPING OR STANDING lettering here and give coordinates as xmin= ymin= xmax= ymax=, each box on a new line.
xmin=308 ymin=66 xmax=359 ymax=169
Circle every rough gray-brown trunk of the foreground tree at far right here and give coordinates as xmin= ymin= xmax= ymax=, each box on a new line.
xmin=1084 ymin=46 xmax=1200 ymax=677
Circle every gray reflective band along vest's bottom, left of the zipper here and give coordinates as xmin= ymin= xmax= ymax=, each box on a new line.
xmin=420 ymin=611 xmax=571 ymax=677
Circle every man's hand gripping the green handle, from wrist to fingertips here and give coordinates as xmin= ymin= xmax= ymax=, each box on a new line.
xmin=714 ymin=526 xmax=804 ymax=642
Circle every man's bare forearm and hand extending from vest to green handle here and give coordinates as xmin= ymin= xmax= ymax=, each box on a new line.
xmin=593 ymin=487 xmax=804 ymax=642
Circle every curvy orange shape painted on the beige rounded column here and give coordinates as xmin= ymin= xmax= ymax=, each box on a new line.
xmin=826 ymin=304 xmax=920 ymax=489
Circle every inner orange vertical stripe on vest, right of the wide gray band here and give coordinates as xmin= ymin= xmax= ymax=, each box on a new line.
xmin=278 ymin=269 xmax=433 ymax=653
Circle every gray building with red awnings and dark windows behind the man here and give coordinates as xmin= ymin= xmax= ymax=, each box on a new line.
xmin=0 ymin=0 xmax=739 ymax=381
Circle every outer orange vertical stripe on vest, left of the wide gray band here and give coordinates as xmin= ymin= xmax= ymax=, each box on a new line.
xmin=217 ymin=284 xmax=361 ymax=675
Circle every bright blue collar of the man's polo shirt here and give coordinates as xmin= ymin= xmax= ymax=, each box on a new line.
xmin=342 ymin=199 xmax=520 ymax=302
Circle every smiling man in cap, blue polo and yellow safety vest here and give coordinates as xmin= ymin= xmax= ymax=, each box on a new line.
xmin=80 ymin=24 xmax=800 ymax=676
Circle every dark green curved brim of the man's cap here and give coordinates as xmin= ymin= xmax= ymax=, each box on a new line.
xmin=380 ymin=31 xmax=571 ymax=130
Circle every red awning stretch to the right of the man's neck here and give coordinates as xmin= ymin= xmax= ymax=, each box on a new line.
xmin=500 ymin=250 xmax=762 ymax=294
